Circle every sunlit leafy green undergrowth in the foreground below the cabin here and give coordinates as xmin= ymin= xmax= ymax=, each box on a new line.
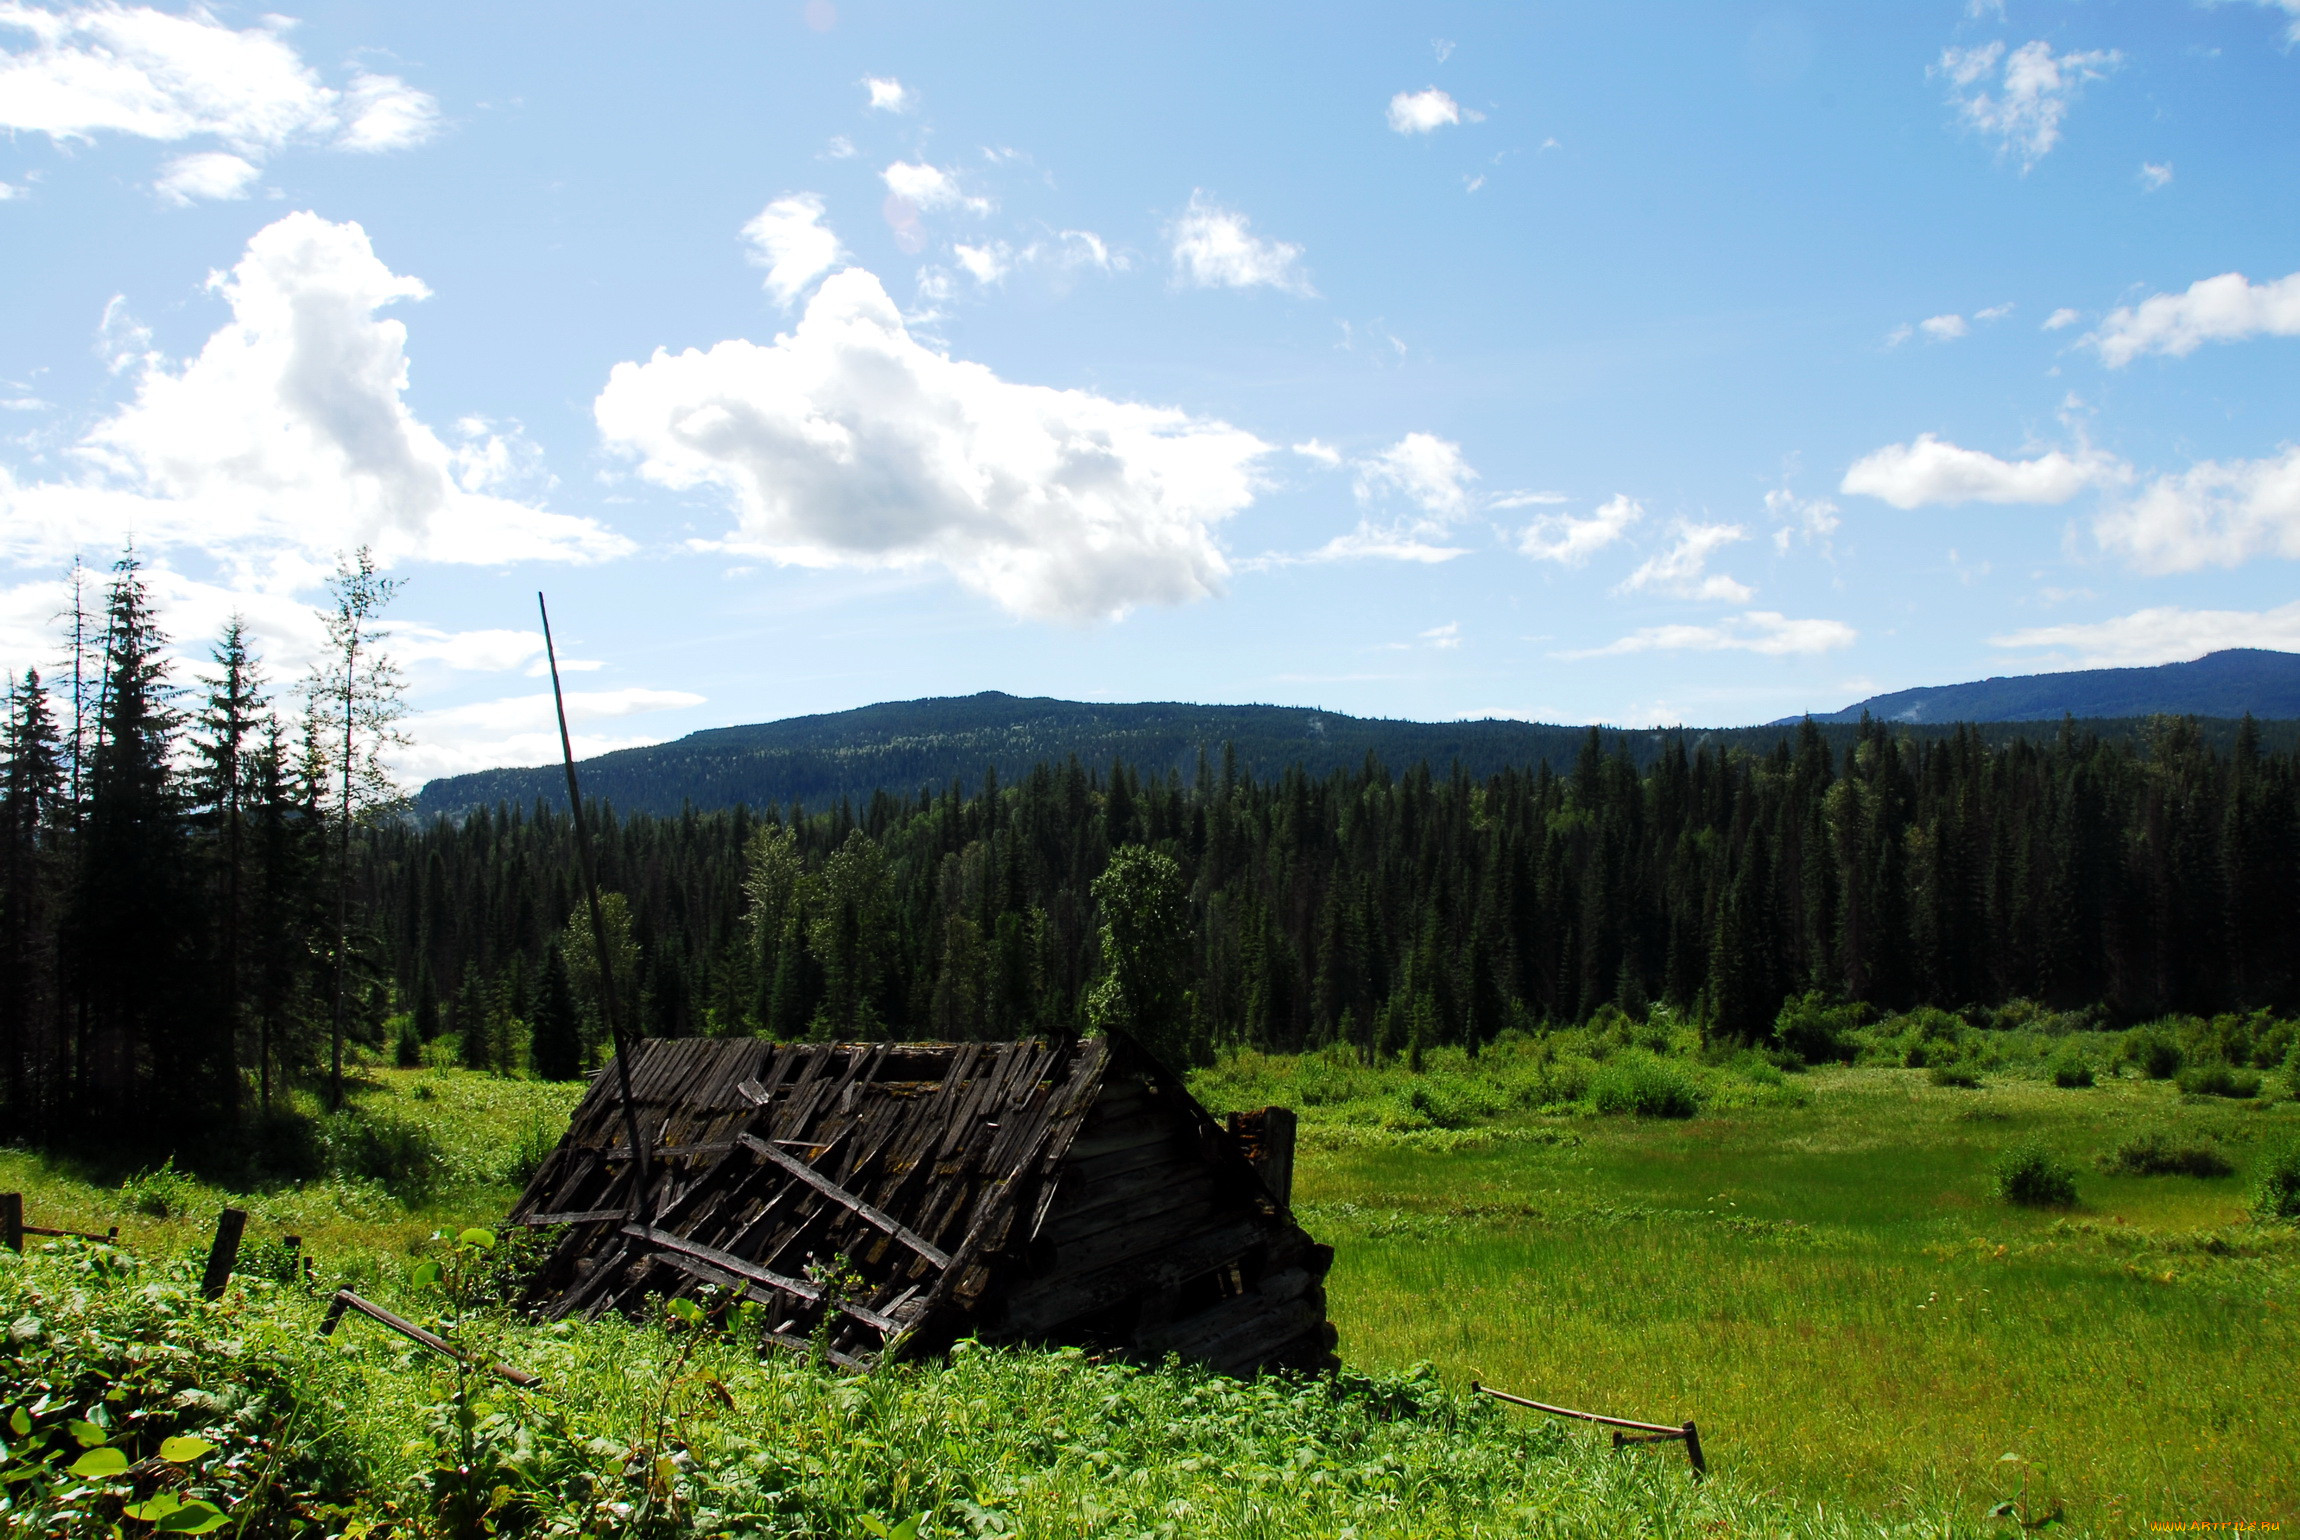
xmin=0 ymin=1230 xmax=1941 ymax=1538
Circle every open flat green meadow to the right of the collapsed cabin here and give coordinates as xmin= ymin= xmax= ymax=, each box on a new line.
xmin=1242 ymin=1069 xmax=2300 ymax=1531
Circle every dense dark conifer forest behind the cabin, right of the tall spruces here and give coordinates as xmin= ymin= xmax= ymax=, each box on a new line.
xmin=361 ymin=719 xmax=2300 ymax=1073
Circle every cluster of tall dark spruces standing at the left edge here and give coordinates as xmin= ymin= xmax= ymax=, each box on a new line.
xmin=0 ymin=552 xmax=400 ymax=1147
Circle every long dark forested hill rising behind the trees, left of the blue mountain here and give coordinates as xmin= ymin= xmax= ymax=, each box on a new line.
xmin=416 ymin=690 xmax=2300 ymax=818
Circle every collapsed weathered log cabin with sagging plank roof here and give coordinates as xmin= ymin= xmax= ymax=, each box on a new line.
xmin=511 ymin=1037 xmax=1334 ymax=1375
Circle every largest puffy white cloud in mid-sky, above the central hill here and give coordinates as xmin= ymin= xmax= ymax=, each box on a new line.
xmin=593 ymin=267 xmax=1270 ymax=623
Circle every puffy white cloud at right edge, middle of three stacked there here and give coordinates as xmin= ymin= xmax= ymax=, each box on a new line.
xmin=2093 ymin=446 xmax=2300 ymax=572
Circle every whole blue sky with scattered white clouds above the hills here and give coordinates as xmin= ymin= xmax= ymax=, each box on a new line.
xmin=0 ymin=0 xmax=2300 ymax=777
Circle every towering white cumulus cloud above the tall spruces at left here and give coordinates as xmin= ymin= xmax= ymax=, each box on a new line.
xmin=0 ymin=214 xmax=630 ymax=570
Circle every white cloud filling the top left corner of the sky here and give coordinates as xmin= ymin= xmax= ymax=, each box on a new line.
xmin=0 ymin=2 xmax=439 ymax=182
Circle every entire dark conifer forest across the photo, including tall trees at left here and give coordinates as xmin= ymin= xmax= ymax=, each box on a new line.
xmin=0 ymin=556 xmax=2300 ymax=1145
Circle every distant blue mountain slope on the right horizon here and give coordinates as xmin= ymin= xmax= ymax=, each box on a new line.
xmin=1785 ymin=648 xmax=2300 ymax=722
